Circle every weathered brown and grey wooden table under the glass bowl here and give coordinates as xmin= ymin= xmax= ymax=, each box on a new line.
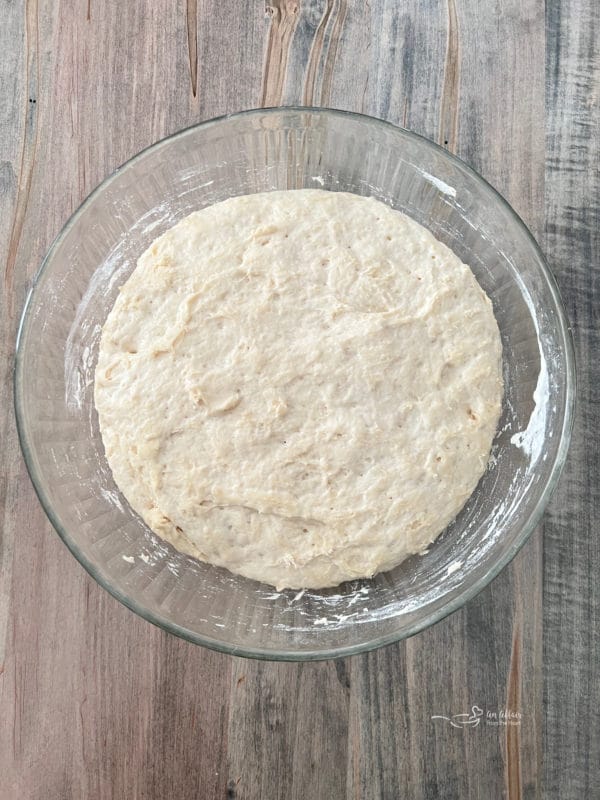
xmin=0 ymin=0 xmax=600 ymax=800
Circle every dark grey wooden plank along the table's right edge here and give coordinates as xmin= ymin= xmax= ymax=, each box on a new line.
xmin=544 ymin=0 xmax=600 ymax=798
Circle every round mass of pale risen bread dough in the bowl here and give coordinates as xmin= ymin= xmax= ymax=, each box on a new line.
xmin=95 ymin=190 xmax=502 ymax=588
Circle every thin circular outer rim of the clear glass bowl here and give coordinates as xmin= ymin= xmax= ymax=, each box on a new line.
xmin=13 ymin=105 xmax=576 ymax=661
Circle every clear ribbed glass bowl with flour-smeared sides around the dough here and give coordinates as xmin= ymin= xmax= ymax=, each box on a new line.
xmin=15 ymin=108 xmax=574 ymax=660
